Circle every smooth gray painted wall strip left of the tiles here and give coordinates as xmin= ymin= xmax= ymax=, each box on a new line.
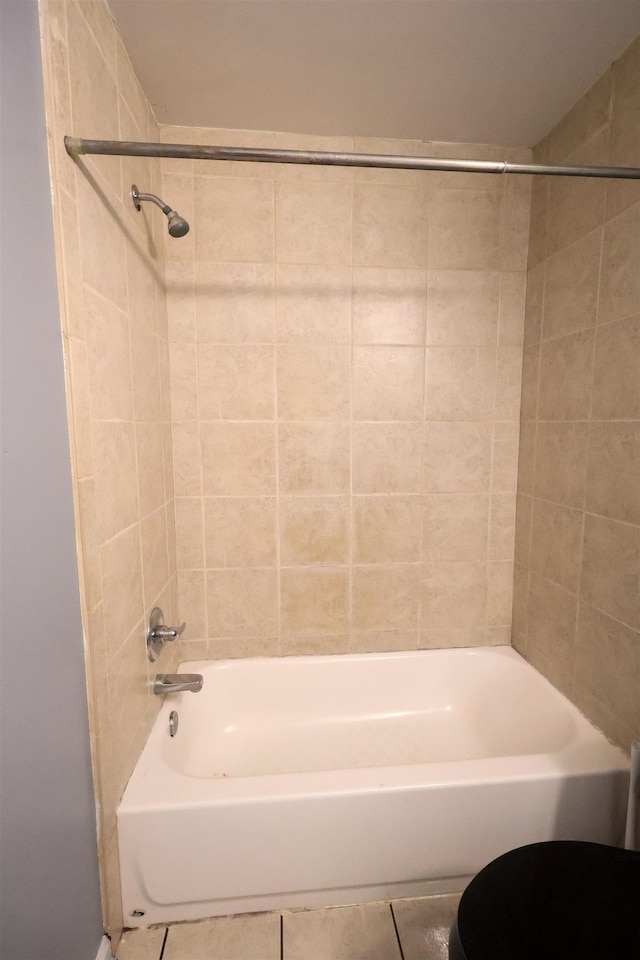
xmin=0 ymin=0 xmax=102 ymax=960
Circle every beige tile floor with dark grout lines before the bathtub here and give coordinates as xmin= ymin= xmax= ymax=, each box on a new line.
xmin=117 ymin=894 xmax=460 ymax=960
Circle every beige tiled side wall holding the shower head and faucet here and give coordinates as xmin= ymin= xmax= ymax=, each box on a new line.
xmin=40 ymin=0 xmax=179 ymax=934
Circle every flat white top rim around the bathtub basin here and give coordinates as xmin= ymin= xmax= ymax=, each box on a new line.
xmin=118 ymin=645 xmax=629 ymax=813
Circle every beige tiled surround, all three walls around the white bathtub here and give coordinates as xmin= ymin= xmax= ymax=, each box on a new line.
xmin=41 ymin=0 xmax=640 ymax=960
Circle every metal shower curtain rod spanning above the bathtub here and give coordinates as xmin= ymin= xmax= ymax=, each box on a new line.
xmin=64 ymin=137 xmax=640 ymax=180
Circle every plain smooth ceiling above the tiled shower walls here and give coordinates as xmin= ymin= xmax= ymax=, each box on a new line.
xmin=109 ymin=0 xmax=640 ymax=146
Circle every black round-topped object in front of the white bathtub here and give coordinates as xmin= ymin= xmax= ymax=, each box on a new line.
xmin=449 ymin=840 xmax=640 ymax=960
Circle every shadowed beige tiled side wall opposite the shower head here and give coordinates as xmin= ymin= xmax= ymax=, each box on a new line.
xmin=513 ymin=38 xmax=640 ymax=749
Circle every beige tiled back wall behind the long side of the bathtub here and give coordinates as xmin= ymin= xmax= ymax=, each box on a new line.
xmin=161 ymin=127 xmax=530 ymax=658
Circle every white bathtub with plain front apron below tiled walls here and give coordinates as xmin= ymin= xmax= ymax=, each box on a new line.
xmin=118 ymin=647 xmax=628 ymax=926
